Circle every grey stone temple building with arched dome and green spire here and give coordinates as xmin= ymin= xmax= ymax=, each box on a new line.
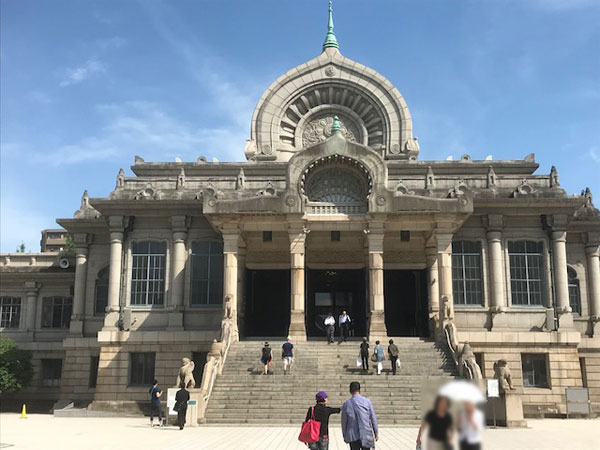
xmin=0 ymin=1 xmax=600 ymax=415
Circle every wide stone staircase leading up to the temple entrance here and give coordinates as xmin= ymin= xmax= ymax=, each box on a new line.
xmin=206 ymin=338 xmax=456 ymax=426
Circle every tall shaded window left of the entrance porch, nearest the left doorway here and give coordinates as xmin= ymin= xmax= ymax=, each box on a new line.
xmin=191 ymin=241 xmax=223 ymax=306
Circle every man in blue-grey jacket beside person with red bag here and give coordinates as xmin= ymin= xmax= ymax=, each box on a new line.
xmin=342 ymin=381 xmax=379 ymax=450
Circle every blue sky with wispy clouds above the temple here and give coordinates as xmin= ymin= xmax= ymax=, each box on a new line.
xmin=0 ymin=0 xmax=600 ymax=252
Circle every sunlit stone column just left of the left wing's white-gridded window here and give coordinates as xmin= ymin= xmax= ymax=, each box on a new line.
xmin=104 ymin=216 xmax=125 ymax=330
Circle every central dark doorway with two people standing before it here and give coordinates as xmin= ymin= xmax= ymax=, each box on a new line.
xmin=306 ymin=269 xmax=367 ymax=337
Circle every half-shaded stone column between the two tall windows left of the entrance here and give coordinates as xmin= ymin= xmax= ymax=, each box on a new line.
xmin=169 ymin=216 xmax=188 ymax=330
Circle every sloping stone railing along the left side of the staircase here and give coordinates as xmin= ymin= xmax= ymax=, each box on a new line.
xmin=198 ymin=320 xmax=233 ymax=423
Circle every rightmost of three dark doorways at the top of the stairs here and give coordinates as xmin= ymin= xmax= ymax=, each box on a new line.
xmin=383 ymin=270 xmax=429 ymax=337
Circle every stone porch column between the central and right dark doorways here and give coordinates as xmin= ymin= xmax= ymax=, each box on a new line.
xmin=367 ymin=227 xmax=387 ymax=340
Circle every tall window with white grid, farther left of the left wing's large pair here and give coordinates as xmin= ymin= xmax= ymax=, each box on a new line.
xmin=131 ymin=241 xmax=167 ymax=306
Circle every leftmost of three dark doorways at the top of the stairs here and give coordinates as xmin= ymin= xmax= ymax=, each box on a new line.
xmin=244 ymin=269 xmax=290 ymax=337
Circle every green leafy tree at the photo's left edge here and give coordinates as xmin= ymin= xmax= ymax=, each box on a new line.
xmin=0 ymin=338 xmax=33 ymax=393
